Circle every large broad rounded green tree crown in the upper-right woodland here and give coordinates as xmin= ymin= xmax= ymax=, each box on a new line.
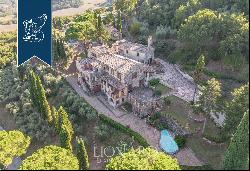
xmin=178 ymin=9 xmax=249 ymax=60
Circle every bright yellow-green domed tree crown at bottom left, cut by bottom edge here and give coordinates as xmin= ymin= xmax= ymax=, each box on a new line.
xmin=20 ymin=145 xmax=79 ymax=170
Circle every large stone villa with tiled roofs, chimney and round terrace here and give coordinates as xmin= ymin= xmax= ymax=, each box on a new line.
xmin=76 ymin=38 xmax=160 ymax=117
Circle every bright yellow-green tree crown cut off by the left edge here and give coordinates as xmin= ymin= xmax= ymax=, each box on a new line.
xmin=0 ymin=131 xmax=30 ymax=166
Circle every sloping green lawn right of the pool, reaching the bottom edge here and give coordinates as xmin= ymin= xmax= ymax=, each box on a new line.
xmin=187 ymin=137 xmax=226 ymax=170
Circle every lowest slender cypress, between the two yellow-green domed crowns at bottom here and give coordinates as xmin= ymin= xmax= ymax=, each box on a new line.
xmin=76 ymin=137 xmax=89 ymax=170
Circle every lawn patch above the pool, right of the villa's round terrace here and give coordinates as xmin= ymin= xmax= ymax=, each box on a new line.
xmin=161 ymin=96 xmax=203 ymax=132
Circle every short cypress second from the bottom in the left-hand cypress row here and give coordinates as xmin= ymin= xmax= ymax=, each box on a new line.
xmin=59 ymin=125 xmax=72 ymax=151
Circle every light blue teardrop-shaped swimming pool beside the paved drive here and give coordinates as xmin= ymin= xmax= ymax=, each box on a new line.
xmin=160 ymin=130 xmax=179 ymax=154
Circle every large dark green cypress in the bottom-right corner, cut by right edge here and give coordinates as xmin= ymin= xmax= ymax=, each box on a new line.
xmin=223 ymin=111 xmax=249 ymax=170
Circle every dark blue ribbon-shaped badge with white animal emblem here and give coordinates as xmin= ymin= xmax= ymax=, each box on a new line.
xmin=17 ymin=0 xmax=52 ymax=66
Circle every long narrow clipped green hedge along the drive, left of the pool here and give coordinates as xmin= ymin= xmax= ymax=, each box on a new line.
xmin=99 ymin=114 xmax=149 ymax=147
